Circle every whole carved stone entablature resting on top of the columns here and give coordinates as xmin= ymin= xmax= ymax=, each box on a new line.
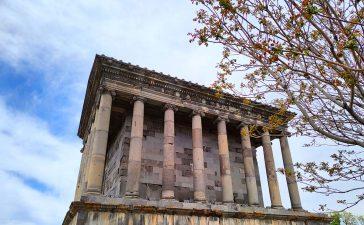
xmin=78 ymin=55 xmax=293 ymax=138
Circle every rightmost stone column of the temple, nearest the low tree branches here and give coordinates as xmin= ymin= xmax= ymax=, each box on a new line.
xmin=279 ymin=134 xmax=302 ymax=210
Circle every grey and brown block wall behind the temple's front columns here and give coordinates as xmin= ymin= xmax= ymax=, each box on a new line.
xmin=103 ymin=111 xmax=262 ymax=203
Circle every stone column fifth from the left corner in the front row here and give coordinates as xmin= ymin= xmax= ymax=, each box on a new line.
xmin=217 ymin=117 xmax=234 ymax=202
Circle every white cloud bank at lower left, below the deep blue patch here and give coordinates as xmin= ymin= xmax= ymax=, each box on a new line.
xmin=0 ymin=98 xmax=81 ymax=225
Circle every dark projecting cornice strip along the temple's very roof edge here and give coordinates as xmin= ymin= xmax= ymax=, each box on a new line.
xmin=77 ymin=54 xmax=295 ymax=138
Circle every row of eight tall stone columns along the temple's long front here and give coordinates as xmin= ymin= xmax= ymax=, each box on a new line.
xmin=86 ymin=91 xmax=302 ymax=209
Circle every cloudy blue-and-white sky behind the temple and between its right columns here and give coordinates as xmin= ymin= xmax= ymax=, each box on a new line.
xmin=0 ymin=0 xmax=364 ymax=225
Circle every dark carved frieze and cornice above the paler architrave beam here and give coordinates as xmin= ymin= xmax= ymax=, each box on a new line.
xmin=78 ymin=55 xmax=292 ymax=138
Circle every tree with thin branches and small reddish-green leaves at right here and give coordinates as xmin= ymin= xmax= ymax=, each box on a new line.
xmin=189 ymin=0 xmax=364 ymax=211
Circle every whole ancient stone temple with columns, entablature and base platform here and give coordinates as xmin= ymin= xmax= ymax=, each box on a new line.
xmin=63 ymin=55 xmax=330 ymax=225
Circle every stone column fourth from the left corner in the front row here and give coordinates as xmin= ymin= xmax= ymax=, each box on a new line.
xmin=192 ymin=111 xmax=206 ymax=201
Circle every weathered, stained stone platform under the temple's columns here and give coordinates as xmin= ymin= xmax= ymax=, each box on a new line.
xmin=63 ymin=195 xmax=331 ymax=225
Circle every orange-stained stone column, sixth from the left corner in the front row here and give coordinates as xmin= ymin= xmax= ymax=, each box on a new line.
xmin=240 ymin=124 xmax=259 ymax=206
